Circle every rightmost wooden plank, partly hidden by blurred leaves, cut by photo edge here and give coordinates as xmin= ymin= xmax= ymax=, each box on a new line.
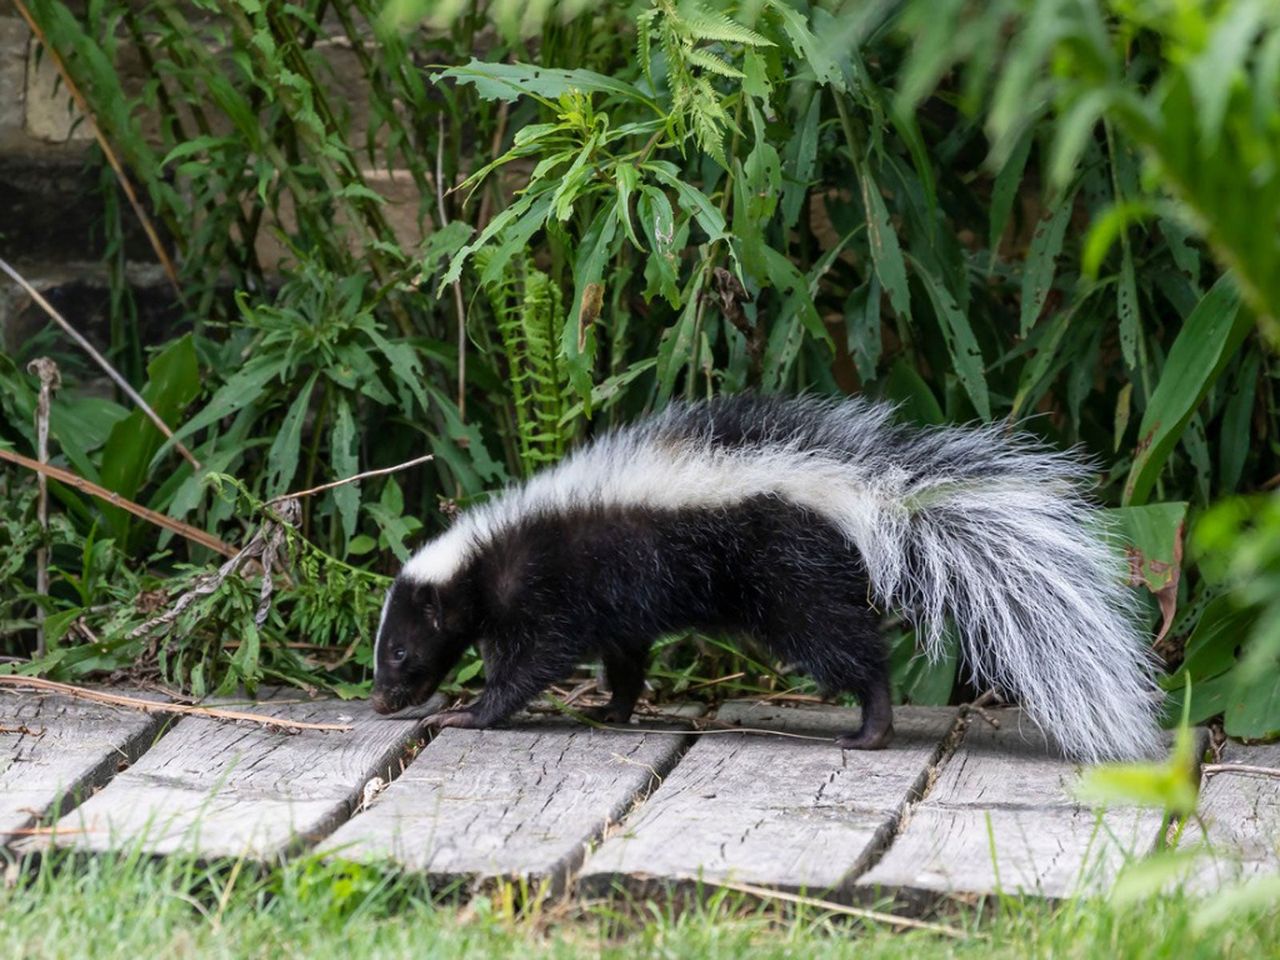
xmin=1180 ymin=742 xmax=1280 ymax=892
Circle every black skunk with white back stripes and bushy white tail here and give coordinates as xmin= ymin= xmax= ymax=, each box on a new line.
xmin=372 ymin=394 xmax=1157 ymax=762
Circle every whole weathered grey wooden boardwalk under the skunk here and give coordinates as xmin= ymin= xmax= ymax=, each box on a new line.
xmin=10 ymin=690 xmax=1280 ymax=906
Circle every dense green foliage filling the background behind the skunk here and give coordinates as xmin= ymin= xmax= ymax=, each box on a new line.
xmin=0 ymin=0 xmax=1280 ymax=731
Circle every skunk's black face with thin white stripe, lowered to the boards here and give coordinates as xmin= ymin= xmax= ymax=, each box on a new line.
xmin=370 ymin=575 xmax=470 ymax=713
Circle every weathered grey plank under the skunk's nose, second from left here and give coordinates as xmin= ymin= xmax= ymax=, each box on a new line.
xmin=37 ymin=690 xmax=424 ymax=860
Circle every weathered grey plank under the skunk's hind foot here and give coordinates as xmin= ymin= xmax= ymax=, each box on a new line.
xmin=579 ymin=703 xmax=955 ymax=895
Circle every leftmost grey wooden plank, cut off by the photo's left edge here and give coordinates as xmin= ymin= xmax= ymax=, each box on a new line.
xmin=0 ymin=687 xmax=165 ymax=846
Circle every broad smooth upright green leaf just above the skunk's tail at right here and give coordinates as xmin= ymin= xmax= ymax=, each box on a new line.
xmin=1124 ymin=276 xmax=1252 ymax=504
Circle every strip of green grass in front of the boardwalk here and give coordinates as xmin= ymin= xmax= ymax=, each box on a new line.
xmin=0 ymin=856 xmax=1280 ymax=960
